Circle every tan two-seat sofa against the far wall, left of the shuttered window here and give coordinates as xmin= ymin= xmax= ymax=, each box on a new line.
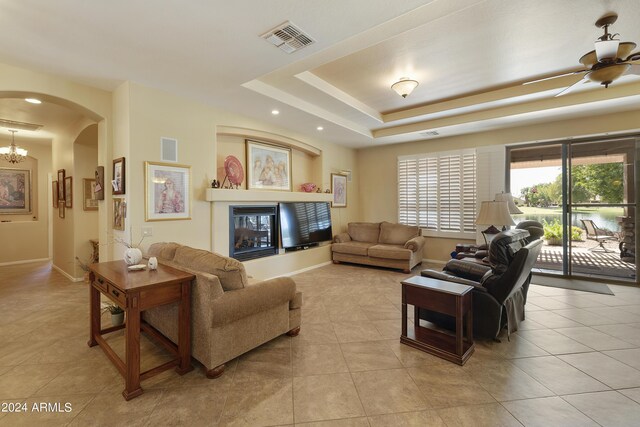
xmin=331 ymin=222 xmax=424 ymax=273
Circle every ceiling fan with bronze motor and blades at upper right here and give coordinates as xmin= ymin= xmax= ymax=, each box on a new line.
xmin=525 ymin=13 xmax=640 ymax=96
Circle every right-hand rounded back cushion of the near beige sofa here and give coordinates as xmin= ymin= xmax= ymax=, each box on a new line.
xmin=174 ymin=246 xmax=248 ymax=291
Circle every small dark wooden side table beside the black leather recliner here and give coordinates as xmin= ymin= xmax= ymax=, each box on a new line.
xmin=400 ymin=276 xmax=475 ymax=365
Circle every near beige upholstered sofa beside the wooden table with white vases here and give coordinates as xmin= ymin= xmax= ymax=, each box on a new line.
xmin=144 ymin=243 xmax=302 ymax=378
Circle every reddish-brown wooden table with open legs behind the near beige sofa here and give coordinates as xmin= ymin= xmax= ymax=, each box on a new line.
xmin=88 ymin=261 xmax=195 ymax=400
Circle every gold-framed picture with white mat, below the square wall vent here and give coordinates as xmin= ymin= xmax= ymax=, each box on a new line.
xmin=144 ymin=162 xmax=191 ymax=221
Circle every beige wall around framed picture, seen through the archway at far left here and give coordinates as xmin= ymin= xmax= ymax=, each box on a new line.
xmin=0 ymin=136 xmax=51 ymax=265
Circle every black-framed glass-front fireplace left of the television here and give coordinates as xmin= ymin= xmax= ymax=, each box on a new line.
xmin=229 ymin=206 xmax=278 ymax=261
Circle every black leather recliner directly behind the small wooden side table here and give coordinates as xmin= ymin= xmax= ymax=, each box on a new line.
xmin=420 ymin=229 xmax=542 ymax=338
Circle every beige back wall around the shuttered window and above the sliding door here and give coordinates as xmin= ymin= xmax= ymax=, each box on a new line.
xmin=357 ymin=110 xmax=640 ymax=261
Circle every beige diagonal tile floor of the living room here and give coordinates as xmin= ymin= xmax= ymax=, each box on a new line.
xmin=0 ymin=263 xmax=640 ymax=427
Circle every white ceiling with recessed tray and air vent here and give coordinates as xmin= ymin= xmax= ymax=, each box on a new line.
xmin=0 ymin=0 xmax=640 ymax=147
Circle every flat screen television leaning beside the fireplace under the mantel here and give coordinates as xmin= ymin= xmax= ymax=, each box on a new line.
xmin=279 ymin=202 xmax=333 ymax=249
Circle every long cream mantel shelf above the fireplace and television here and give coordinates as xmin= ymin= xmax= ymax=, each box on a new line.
xmin=205 ymin=188 xmax=333 ymax=202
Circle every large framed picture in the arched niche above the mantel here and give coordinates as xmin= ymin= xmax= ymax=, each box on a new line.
xmin=246 ymin=139 xmax=291 ymax=191
